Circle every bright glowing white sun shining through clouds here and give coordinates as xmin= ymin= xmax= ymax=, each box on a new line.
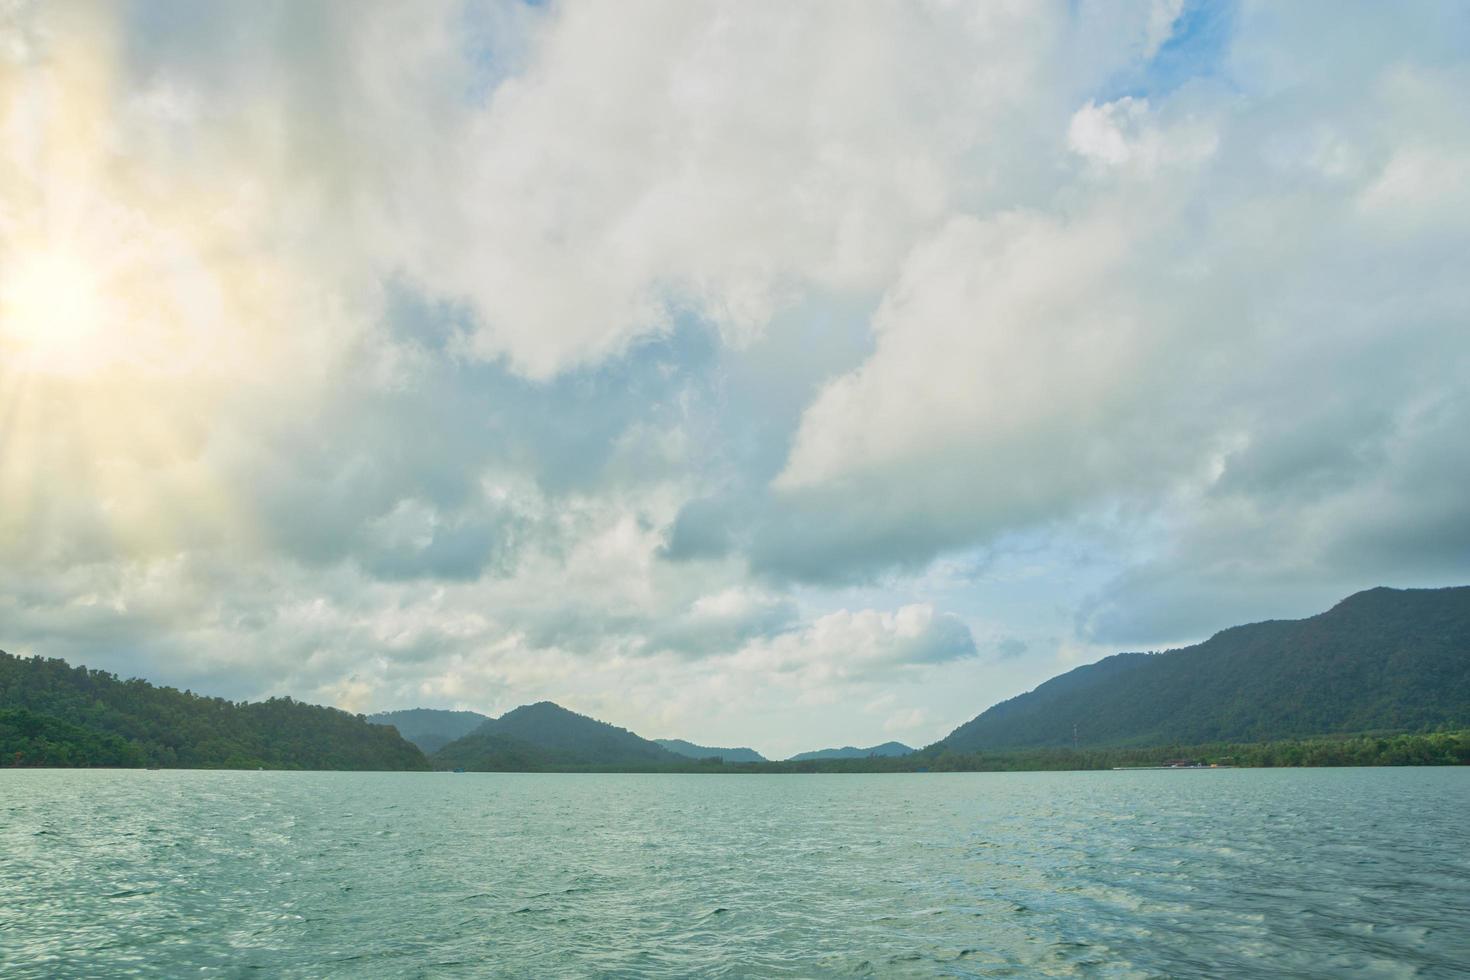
xmin=0 ymin=248 xmax=107 ymax=375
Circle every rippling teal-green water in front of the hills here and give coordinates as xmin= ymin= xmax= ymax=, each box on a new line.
xmin=0 ymin=768 xmax=1470 ymax=979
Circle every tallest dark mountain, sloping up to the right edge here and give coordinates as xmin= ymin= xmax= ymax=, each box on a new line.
xmin=931 ymin=586 xmax=1470 ymax=752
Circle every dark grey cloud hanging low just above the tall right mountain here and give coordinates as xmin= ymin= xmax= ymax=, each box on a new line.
xmin=1079 ymin=387 xmax=1470 ymax=646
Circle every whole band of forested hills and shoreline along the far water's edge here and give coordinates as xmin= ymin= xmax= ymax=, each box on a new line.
xmin=0 ymin=586 xmax=1470 ymax=773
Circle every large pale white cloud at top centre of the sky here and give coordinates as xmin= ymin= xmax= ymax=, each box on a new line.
xmin=387 ymin=3 xmax=1146 ymax=376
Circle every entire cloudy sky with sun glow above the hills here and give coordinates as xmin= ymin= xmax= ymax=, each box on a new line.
xmin=0 ymin=0 xmax=1470 ymax=757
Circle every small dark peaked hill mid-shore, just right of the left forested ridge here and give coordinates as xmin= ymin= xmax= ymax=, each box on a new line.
xmin=432 ymin=701 xmax=688 ymax=771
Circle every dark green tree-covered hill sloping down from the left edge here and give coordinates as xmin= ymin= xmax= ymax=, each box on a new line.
xmin=0 ymin=652 xmax=429 ymax=770
